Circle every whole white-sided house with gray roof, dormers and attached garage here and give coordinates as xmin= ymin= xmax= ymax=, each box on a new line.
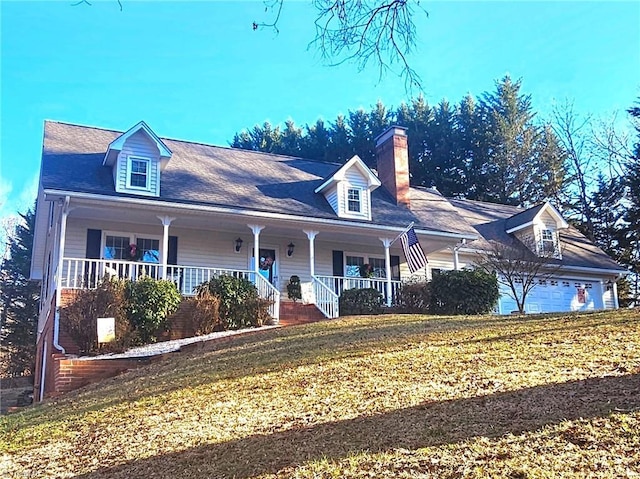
xmin=31 ymin=121 xmax=624 ymax=400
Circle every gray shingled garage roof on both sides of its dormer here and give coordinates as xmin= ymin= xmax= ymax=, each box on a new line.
xmin=449 ymin=199 xmax=623 ymax=271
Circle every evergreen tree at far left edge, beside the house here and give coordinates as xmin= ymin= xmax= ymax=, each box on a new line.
xmin=0 ymin=210 xmax=40 ymax=376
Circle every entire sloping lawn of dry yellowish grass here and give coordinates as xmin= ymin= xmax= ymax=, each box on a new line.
xmin=0 ymin=311 xmax=640 ymax=479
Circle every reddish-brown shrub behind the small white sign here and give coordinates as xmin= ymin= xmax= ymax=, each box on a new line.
xmin=60 ymin=278 xmax=131 ymax=354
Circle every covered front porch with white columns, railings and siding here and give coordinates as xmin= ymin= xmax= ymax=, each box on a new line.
xmin=50 ymin=197 xmax=472 ymax=320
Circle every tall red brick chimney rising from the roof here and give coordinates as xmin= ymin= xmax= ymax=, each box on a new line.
xmin=376 ymin=126 xmax=411 ymax=208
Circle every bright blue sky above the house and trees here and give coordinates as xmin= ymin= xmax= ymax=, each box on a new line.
xmin=0 ymin=0 xmax=640 ymax=224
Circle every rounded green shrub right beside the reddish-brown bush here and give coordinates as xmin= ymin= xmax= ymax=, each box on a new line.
xmin=125 ymin=276 xmax=182 ymax=344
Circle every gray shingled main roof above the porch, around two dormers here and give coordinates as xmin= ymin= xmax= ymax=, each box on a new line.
xmin=42 ymin=121 xmax=476 ymax=235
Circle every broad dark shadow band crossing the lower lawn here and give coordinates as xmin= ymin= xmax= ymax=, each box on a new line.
xmin=71 ymin=374 xmax=640 ymax=479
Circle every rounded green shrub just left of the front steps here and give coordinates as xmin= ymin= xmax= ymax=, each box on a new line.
xmin=196 ymin=275 xmax=270 ymax=330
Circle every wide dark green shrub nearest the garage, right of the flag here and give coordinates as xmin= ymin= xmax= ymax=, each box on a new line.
xmin=429 ymin=268 xmax=500 ymax=314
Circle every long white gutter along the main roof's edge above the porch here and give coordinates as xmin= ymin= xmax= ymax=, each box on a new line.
xmin=44 ymin=189 xmax=478 ymax=240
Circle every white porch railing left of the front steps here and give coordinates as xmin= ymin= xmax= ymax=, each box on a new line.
xmin=60 ymin=258 xmax=280 ymax=320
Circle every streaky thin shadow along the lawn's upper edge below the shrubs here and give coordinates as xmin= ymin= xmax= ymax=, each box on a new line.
xmin=24 ymin=317 xmax=640 ymax=426
